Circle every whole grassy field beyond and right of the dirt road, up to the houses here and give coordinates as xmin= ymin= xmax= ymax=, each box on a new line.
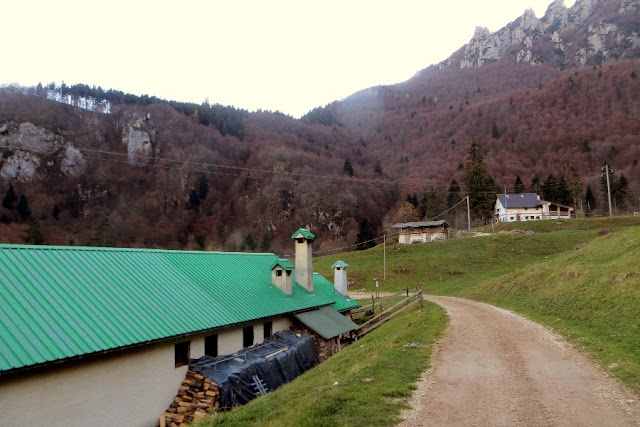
xmin=316 ymin=217 xmax=640 ymax=392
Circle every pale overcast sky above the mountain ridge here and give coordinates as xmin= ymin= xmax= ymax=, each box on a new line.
xmin=0 ymin=0 xmax=575 ymax=117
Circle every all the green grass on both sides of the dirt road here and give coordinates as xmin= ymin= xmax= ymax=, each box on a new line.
xmin=198 ymin=217 xmax=640 ymax=426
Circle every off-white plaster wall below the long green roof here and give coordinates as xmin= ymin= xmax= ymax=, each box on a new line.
xmin=0 ymin=318 xmax=292 ymax=427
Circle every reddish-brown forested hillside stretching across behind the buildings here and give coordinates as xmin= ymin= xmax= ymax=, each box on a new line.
xmin=0 ymin=0 xmax=640 ymax=254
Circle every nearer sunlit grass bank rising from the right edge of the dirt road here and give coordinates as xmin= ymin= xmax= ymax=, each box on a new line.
xmin=460 ymin=227 xmax=640 ymax=392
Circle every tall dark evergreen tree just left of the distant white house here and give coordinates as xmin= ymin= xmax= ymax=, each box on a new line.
xmin=464 ymin=142 xmax=499 ymax=218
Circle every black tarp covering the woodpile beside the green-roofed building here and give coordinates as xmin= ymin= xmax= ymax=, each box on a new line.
xmin=190 ymin=332 xmax=318 ymax=409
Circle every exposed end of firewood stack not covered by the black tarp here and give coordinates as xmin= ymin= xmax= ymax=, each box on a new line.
xmin=160 ymin=370 xmax=220 ymax=427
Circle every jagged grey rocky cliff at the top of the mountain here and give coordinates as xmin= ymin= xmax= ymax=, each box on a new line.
xmin=438 ymin=0 xmax=640 ymax=68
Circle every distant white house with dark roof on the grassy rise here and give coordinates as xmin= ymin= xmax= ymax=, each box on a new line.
xmin=494 ymin=193 xmax=575 ymax=222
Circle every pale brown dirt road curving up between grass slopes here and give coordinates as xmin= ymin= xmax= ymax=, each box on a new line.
xmin=400 ymin=296 xmax=640 ymax=426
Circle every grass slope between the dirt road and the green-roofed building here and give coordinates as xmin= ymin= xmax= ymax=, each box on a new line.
xmin=196 ymin=303 xmax=447 ymax=427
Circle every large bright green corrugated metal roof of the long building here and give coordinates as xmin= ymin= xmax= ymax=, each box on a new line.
xmin=0 ymin=245 xmax=343 ymax=373
